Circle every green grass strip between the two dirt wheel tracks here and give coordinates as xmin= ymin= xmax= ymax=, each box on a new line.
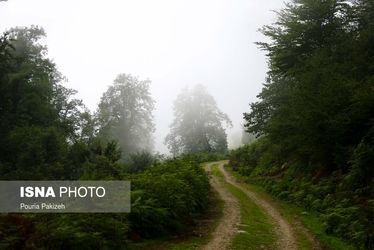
xmin=212 ymin=165 xmax=276 ymax=250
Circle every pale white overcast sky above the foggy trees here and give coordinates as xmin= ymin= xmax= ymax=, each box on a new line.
xmin=0 ymin=0 xmax=284 ymax=153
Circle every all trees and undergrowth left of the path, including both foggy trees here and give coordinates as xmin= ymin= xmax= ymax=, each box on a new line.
xmin=0 ymin=26 xmax=230 ymax=249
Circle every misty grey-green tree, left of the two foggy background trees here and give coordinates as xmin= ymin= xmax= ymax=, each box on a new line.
xmin=97 ymin=74 xmax=155 ymax=157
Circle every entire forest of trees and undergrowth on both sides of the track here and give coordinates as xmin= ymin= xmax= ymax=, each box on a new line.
xmin=0 ymin=0 xmax=374 ymax=249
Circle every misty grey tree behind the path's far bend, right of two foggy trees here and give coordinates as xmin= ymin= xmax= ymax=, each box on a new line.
xmin=165 ymin=85 xmax=231 ymax=155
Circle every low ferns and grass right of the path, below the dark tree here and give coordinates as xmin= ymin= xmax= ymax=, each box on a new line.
xmin=230 ymin=145 xmax=364 ymax=249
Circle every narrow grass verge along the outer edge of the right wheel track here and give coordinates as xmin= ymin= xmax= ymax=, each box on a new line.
xmin=228 ymin=169 xmax=356 ymax=250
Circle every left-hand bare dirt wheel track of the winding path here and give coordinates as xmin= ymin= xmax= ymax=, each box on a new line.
xmin=202 ymin=163 xmax=240 ymax=250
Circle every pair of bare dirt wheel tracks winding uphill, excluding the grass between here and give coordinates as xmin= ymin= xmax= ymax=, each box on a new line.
xmin=203 ymin=162 xmax=298 ymax=250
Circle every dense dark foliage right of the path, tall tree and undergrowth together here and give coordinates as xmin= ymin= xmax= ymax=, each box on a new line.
xmin=231 ymin=0 xmax=374 ymax=248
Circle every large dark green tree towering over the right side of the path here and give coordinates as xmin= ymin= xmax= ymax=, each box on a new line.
xmin=244 ymin=0 xmax=374 ymax=170
